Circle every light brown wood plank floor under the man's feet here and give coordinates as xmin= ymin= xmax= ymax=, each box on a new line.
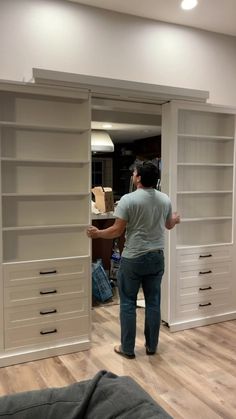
xmin=0 ymin=305 xmax=236 ymax=419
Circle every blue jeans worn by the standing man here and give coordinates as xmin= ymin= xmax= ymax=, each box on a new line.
xmin=118 ymin=251 xmax=164 ymax=354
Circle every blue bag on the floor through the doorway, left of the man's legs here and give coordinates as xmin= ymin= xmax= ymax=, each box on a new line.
xmin=92 ymin=262 xmax=113 ymax=303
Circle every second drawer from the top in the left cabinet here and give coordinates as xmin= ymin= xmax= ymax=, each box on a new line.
xmin=4 ymin=278 xmax=89 ymax=307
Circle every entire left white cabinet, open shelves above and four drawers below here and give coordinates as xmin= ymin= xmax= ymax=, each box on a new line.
xmin=0 ymin=84 xmax=90 ymax=365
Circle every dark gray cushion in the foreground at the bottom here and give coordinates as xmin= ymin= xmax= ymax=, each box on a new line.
xmin=0 ymin=371 xmax=171 ymax=419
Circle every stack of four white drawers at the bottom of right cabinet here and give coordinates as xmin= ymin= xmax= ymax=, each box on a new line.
xmin=176 ymin=246 xmax=233 ymax=320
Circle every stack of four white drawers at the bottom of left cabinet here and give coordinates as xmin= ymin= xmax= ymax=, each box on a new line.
xmin=3 ymin=258 xmax=89 ymax=351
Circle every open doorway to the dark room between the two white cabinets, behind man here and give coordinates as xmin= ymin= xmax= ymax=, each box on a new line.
xmin=91 ymin=100 xmax=161 ymax=307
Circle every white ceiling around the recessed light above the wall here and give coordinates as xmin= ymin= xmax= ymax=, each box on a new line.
xmin=69 ymin=0 xmax=236 ymax=36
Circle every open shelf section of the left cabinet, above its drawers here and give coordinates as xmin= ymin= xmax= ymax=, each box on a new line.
xmin=1 ymin=93 xmax=90 ymax=262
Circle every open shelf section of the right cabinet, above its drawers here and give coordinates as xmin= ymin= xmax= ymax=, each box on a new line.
xmin=177 ymin=109 xmax=235 ymax=246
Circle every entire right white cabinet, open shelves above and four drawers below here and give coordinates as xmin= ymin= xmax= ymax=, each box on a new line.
xmin=162 ymin=103 xmax=236 ymax=330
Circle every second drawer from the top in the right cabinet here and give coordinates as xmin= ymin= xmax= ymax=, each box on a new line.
xmin=177 ymin=262 xmax=232 ymax=289
